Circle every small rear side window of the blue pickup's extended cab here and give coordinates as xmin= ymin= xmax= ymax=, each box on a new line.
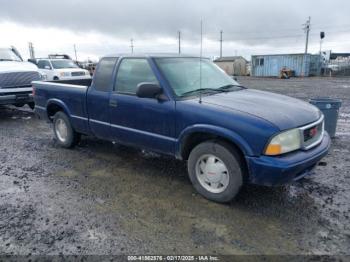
xmin=94 ymin=57 xmax=118 ymax=92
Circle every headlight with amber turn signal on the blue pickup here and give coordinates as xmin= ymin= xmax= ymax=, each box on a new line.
xmin=265 ymin=129 xmax=301 ymax=156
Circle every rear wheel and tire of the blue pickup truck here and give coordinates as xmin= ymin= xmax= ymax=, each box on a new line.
xmin=53 ymin=111 xmax=80 ymax=148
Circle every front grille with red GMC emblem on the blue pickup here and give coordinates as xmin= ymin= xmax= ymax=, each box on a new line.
xmin=300 ymin=116 xmax=324 ymax=150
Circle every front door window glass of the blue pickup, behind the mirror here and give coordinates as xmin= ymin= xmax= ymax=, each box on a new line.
xmin=116 ymin=58 xmax=158 ymax=94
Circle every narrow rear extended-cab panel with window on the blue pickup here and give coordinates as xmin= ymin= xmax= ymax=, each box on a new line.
xmin=87 ymin=57 xmax=117 ymax=139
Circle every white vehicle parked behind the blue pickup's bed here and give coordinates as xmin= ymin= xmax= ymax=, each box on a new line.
xmin=37 ymin=58 xmax=91 ymax=80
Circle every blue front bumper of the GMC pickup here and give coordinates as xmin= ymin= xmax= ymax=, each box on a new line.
xmin=246 ymin=132 xmax=330 ymax=186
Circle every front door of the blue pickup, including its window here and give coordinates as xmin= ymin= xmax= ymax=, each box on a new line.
xmin=109 ymin=58 xmax=176 ymax=154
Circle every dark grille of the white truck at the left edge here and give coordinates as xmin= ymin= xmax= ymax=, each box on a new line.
xmin=0 ymin=71 xmax=40 ymax=88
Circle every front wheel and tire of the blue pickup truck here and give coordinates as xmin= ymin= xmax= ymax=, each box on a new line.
xmin=187 ymin=141 xmax=245 ymax=203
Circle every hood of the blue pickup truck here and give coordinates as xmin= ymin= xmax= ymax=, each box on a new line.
xmin=198 ymin=89 xmax=321 ymax=130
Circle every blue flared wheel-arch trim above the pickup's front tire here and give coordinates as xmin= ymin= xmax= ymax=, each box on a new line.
xmin=175 ymin=124 xmax=254 ymax=157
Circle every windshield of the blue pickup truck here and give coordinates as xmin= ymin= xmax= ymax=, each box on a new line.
xmin=155 ymin=57 xmax=242 ymax=97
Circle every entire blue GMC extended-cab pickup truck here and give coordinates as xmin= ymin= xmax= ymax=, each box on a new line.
xmin=33 ymin=54 xmax=330 ymax=202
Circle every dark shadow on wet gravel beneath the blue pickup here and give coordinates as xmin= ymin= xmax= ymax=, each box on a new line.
xmin=79 ymin=137 xmax=314 ymax=216
